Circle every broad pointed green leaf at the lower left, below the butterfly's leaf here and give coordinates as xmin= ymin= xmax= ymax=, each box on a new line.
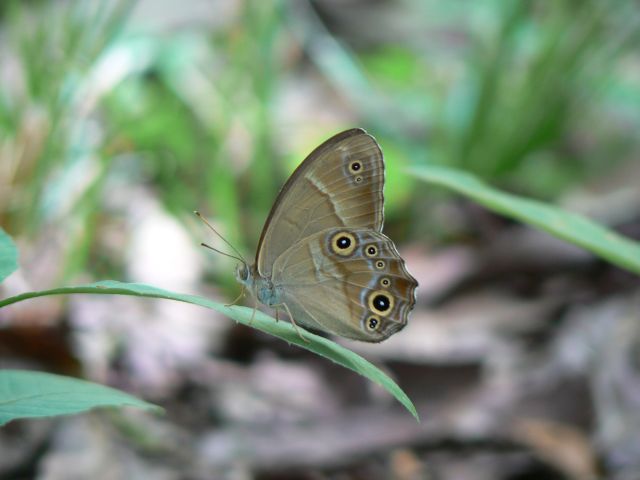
xmin=0 ymin=370 xmax=162 ymax=426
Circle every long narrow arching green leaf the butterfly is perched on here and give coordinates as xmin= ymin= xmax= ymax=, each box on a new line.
xmin=0 ymin=280 xmax=419 ymax=420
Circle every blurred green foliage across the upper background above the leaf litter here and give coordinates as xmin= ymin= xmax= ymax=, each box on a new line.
xmin=0 ymin=0 xmax=640 ymax=288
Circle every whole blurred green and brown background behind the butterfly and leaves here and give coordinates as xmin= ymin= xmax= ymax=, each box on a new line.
xmin=0 ymin=0 xmax=640 ymax=480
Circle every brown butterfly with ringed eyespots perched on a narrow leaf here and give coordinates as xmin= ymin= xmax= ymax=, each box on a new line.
xmin=202 ymin=128 xmax=418 ymax=342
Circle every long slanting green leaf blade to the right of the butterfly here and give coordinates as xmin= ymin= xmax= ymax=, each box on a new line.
xmin=409 ymin=165 xmax=640 ymax=274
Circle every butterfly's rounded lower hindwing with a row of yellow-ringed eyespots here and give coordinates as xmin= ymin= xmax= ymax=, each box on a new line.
xmin=272 ymin=228 xmax=418 ymax=342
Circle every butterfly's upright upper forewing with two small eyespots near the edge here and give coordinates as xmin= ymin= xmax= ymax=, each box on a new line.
xmin=256 ymin=128 xmax=384 ymax=277
